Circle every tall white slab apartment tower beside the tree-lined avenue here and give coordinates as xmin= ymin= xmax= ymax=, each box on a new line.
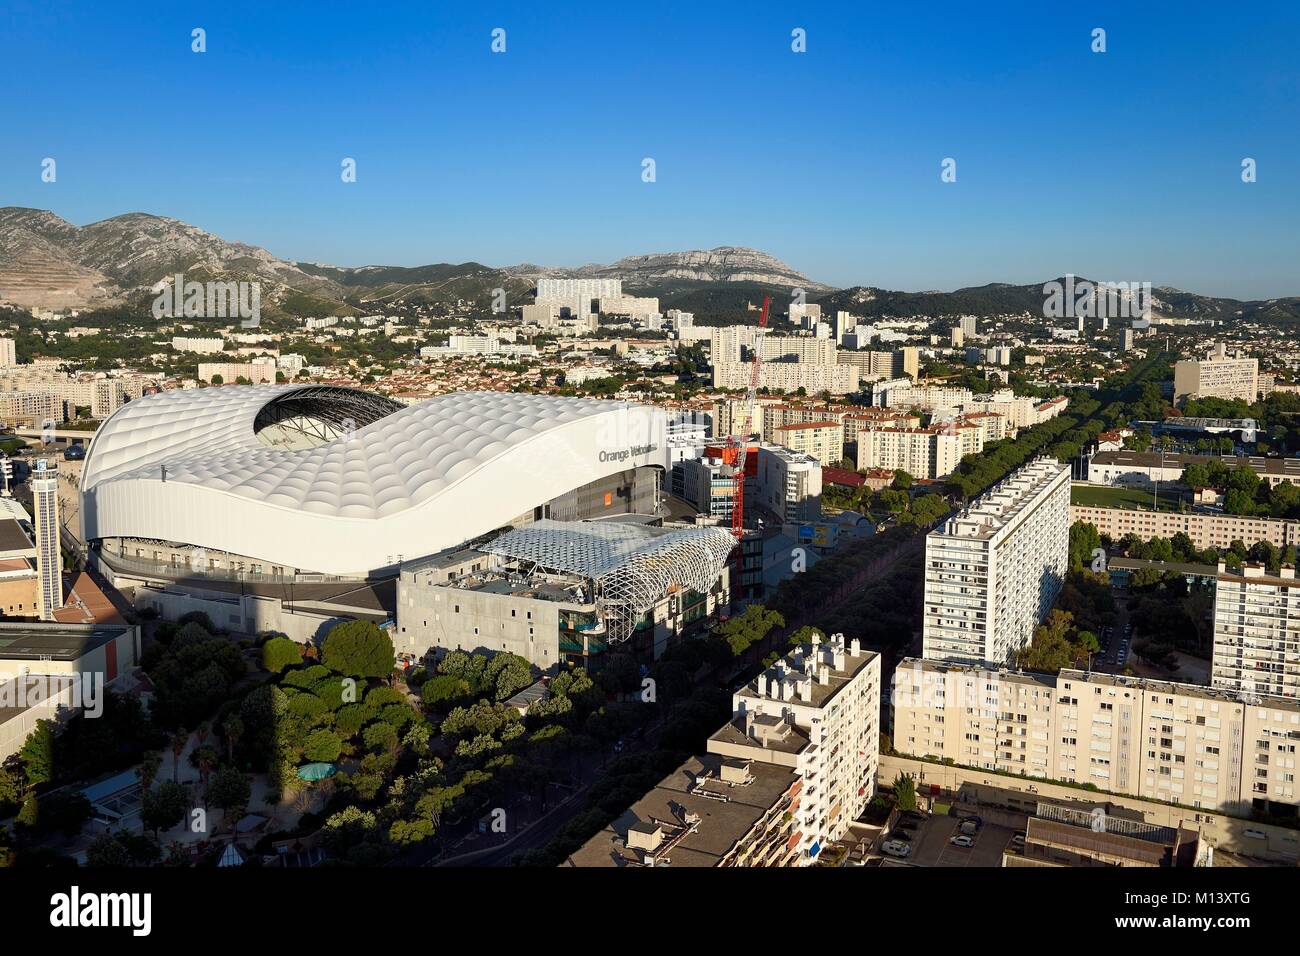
xmin=920 ymin=455 xmax=1070 ymax=666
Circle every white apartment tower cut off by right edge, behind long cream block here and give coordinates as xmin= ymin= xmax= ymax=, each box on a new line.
xmin=1210 ymin=562 xmax=1300 ymax=697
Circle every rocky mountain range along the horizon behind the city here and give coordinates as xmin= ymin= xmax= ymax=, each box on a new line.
xmin=0 ymin=207 xmax=1300 ymax=321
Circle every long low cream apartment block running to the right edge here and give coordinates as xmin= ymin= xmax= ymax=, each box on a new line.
xmin=892 ymin=659 xmax=1300 ymax=816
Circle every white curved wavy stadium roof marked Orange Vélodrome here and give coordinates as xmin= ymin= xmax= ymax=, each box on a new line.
xmin=81 ymin=385 xmax=667 ymax=574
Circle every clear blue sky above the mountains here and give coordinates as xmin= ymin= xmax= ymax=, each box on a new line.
xmin=0 ymin=0 xmax=1300 ymax=298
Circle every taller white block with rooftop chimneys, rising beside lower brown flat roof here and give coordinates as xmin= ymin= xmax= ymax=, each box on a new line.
xmin=709 ymin=635 xmax=880 ymax=864
